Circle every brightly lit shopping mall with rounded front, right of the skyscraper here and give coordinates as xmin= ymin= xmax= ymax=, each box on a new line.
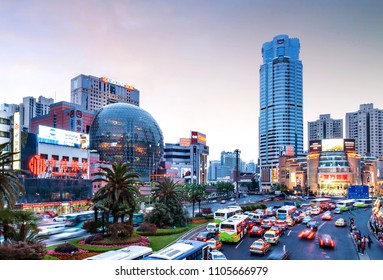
xmin=280 ymin=139 xmax=383 ymax=196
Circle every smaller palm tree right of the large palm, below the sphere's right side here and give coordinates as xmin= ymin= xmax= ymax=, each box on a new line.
xmin=152 ymin=177 xmax=183 ymax=204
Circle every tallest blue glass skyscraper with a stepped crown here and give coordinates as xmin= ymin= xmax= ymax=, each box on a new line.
xmin=259 ymin=35 xmax=303 ymax=188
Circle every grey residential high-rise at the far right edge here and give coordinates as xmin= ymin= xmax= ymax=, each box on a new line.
xmin=346 ymin=103 xmax=383 ymax=157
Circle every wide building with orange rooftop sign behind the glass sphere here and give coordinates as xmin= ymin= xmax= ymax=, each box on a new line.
xmin=71 ymin=74 xmax=140 ymax=111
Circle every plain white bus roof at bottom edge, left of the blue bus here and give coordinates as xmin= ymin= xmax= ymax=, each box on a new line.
xmin=84 ymin=245 xmax=153 ymax=260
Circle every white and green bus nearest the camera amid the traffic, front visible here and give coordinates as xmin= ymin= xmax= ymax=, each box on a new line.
xmin=218 ymin=215 xmax=250 ymax=243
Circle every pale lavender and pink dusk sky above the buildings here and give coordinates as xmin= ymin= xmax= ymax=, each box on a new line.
xmin=0 ymin=0 xmax=383 ymax=162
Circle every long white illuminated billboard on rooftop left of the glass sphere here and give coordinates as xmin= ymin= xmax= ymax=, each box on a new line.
xmin=38 ymin=125 xmax=89 ymax=149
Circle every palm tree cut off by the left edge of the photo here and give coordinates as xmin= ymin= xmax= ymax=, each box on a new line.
xmin=0 ymin=143 xmax=25 ymax=209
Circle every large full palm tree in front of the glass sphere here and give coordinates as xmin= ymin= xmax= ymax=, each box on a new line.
xmin=92 ymin=162 xmax=141 ymax=224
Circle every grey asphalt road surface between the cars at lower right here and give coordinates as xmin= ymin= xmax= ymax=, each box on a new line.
xmin=186 ymin=198 xmax=383 ymax=260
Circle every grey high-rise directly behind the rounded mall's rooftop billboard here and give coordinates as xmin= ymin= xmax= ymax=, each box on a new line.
xmin=308 ymin=114 xmax=343 ymax=144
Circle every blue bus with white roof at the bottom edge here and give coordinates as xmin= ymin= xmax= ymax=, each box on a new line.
xmin=142 ymin=240 xmax=210 ymax=260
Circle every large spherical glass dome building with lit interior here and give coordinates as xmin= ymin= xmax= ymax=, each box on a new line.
xmin=89 ymin=103 xmax=164 ymax=181
